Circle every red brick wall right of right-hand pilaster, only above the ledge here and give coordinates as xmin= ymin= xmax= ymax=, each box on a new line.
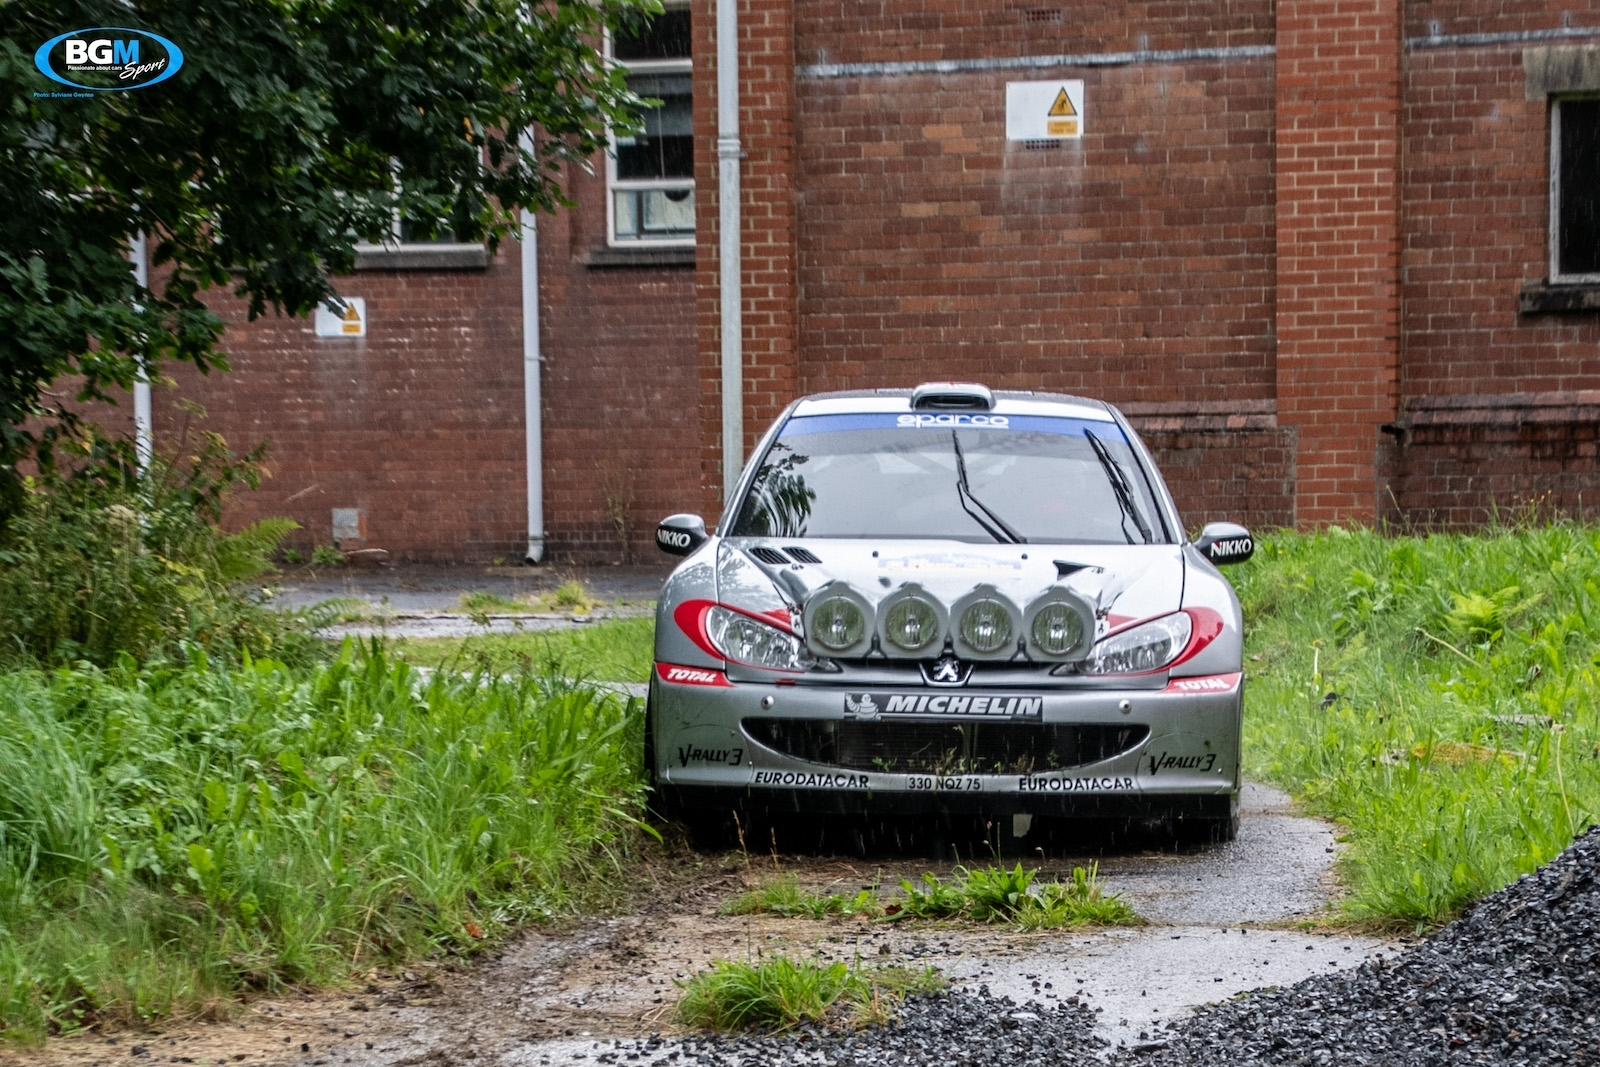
xmin=1402 ymin=21 xmax=1600 ymax=397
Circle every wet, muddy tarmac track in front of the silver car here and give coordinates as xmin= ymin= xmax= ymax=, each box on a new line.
xmin=0 ymin=784 xmax=1398 ymax=1067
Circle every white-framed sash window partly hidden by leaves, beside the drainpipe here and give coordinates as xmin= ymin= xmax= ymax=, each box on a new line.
xmin=606 ymin=5 xmax=694 ymax=246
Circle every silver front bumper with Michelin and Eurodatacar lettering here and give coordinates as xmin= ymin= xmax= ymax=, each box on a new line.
xmin=650 ymin=665 xmax=1243 ymax=817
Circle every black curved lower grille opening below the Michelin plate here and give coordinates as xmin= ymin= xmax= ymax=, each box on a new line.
xmin=744 ymin=718 xmax=1150 ymax=774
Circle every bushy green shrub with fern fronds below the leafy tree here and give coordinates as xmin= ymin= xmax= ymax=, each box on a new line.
xmin=0 ymin=432 xmax=302 ymax=665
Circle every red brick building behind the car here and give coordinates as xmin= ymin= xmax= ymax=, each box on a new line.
xmin=157 ymin=0 xmax=1600 ymax=560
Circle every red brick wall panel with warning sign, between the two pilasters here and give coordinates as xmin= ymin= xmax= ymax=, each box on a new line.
xmin=797 ymin=0 xmax=1274 ymax=412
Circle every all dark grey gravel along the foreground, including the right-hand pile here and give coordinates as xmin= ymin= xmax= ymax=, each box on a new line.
xmin=556 ymin=827 xmax=1600 ymax=1067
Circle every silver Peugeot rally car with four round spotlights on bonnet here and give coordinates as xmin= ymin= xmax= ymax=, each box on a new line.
xmin=645 ymin=382 xmax=1254 ymax=840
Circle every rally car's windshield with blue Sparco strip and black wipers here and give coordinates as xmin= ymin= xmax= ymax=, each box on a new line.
xmin=730 ymin=413 xmax=1168 ymax=544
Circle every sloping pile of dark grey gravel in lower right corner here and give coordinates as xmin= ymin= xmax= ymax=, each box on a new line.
xmin=1118 ymin=827 xmax=1600 ymax=1067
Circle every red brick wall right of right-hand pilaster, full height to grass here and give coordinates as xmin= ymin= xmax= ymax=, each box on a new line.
xmin=1395 ymin=0 xmax=1600 ymax=528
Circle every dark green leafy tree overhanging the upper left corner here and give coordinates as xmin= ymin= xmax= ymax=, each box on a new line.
xmin=0 ymin=0 xmax=659 ymax=522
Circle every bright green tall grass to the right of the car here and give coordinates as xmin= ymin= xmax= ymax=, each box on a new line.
xmin=1230 ymin=525 xmax=1600 ymax=923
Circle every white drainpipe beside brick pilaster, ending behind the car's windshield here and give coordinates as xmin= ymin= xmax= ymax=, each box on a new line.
xmin=717 ymin=0 xmax=744 ymax=501
